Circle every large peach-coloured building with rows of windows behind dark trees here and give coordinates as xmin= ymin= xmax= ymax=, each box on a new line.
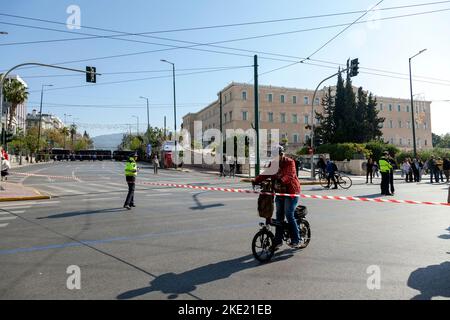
xmin=183 ymin=82 xmax=432 ymax=150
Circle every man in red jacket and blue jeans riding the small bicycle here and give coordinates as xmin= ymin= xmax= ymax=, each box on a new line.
xmin=252 ymin=146 xmax=303 ymax=249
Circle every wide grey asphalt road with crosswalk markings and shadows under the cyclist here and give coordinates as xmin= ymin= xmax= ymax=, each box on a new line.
xmin=0 ymin=162 xmax=450 ymax=300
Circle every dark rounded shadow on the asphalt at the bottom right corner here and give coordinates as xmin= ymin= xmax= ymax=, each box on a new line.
xmin=408 ymin=227 xmax=450 ymax=300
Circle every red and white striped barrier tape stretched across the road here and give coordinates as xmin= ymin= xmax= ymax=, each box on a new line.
xmin=137 ymin=182 xmax=450 ymax=206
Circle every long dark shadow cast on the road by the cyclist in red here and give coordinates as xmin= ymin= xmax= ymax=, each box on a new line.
xmin=117 ymin=255 xmax=292 ymax=300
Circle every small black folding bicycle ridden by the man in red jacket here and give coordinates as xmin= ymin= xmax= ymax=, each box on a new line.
xmin=252 ymin=181 xmax=311 ymax=263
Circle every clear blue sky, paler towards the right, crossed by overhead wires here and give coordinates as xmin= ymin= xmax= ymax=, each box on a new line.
xmin=0 ymin=0 xmax=450 ymax=136
